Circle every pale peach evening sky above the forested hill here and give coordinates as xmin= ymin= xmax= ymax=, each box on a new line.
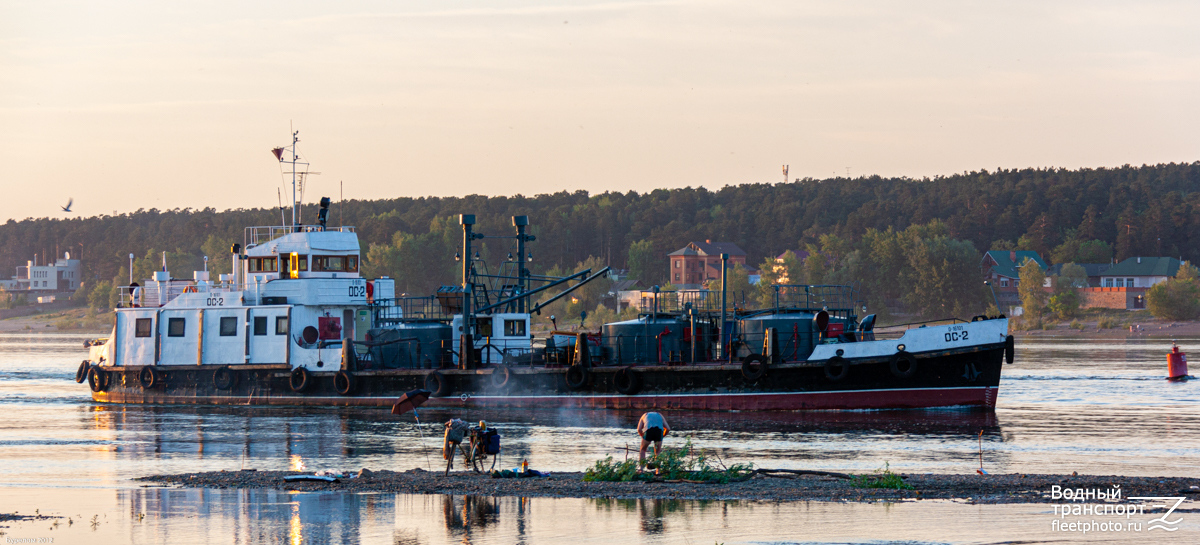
xmin=0 ymin=0 xmax=1200 ymax=221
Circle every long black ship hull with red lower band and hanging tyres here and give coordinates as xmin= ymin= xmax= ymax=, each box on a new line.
xmin=92 ymin=343 xmax=1004 ymax=411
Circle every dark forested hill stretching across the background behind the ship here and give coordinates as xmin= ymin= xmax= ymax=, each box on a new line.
xmin=0 ymin=162 xmax=1200 ymax=306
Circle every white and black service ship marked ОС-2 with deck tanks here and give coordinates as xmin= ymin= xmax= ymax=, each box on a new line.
xmin=76 ymin=133 xmax=1014 ymax=411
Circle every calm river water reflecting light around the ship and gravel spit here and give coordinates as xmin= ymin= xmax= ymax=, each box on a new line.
xmin=0 ymin=335 xmax=1200 ymax=545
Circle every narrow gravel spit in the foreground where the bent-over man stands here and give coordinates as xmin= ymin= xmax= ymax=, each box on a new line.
xmin=134 ymin=468 xmax=1200 ymax=504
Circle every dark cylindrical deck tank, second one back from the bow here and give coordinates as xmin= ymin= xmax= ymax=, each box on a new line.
xmin=602 ymin=315 xmax=690 ymax=364
